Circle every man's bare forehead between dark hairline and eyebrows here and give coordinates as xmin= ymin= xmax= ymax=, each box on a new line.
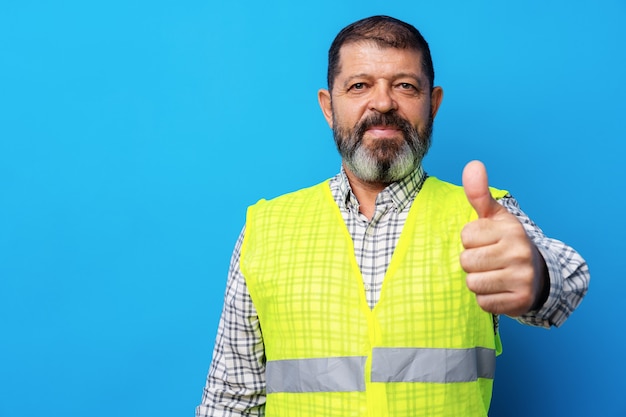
xmin=335 ymin=42 xmax=425 ymax=79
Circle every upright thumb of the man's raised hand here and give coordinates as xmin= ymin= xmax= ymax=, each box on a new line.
xmin=463 ymin=161 xmax=501 ymax=218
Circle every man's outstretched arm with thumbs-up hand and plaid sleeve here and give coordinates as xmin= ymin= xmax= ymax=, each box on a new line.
xmin=460 ymin=161 xmax=589 ymax=326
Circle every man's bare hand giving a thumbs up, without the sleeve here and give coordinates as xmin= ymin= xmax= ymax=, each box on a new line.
xmin=460 ymin=161 xmax=549 ymax=317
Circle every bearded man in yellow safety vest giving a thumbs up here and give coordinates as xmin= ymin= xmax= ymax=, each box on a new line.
xmin=196 ymin=16 xmax=589 ymax=417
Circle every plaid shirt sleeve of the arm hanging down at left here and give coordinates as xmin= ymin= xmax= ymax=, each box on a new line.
xmin=196 ymin=227 xmax=265 ymax=417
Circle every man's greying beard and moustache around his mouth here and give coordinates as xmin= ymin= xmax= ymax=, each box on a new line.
xmin=333 ymin=113 xmax=433 ymax=184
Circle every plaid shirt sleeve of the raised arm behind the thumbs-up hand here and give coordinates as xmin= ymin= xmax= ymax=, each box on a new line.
xmin=498 ymin=195 xmax=589 ymax=328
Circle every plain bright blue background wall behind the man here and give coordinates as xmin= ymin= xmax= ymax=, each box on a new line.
xmin=0 ymin=0 xmax=626 ymax=417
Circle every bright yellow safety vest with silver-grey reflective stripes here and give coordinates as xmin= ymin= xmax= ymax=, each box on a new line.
xmin=240 ymin=177 xmax=506 ymax=417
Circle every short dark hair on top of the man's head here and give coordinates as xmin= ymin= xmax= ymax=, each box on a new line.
xmin=327 ymin=16 xmax=435 ymax=91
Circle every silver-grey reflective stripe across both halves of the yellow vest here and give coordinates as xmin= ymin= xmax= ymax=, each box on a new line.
xmin=266 ymin=347 xmax=496 ymax=394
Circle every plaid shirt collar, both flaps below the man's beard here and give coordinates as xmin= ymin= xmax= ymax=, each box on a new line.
xmin=337 ymin=164 xmax=428 ymax=212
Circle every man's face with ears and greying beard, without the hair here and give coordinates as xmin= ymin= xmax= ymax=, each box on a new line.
xmin=319 ymin=42 xmax=442 ymax=184
